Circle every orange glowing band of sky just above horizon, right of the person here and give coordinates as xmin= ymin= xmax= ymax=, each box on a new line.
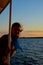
xmin=21 ymin=32 xmax=43 ymax=37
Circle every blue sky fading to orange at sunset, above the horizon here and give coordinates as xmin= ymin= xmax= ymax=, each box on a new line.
xmin=0 ymin=0 xmax=43 ymax=37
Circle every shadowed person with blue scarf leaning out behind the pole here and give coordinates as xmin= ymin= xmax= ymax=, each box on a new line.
xmin=0 ymin=22 xmax=22 ymax=65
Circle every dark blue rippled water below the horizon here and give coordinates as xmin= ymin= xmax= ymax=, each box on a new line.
xmin=11 ymin=38 xmax=43 ymax=65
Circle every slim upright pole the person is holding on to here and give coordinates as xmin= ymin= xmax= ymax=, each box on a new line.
xmin=8 ymin=0 xmax=12 ymax=65
